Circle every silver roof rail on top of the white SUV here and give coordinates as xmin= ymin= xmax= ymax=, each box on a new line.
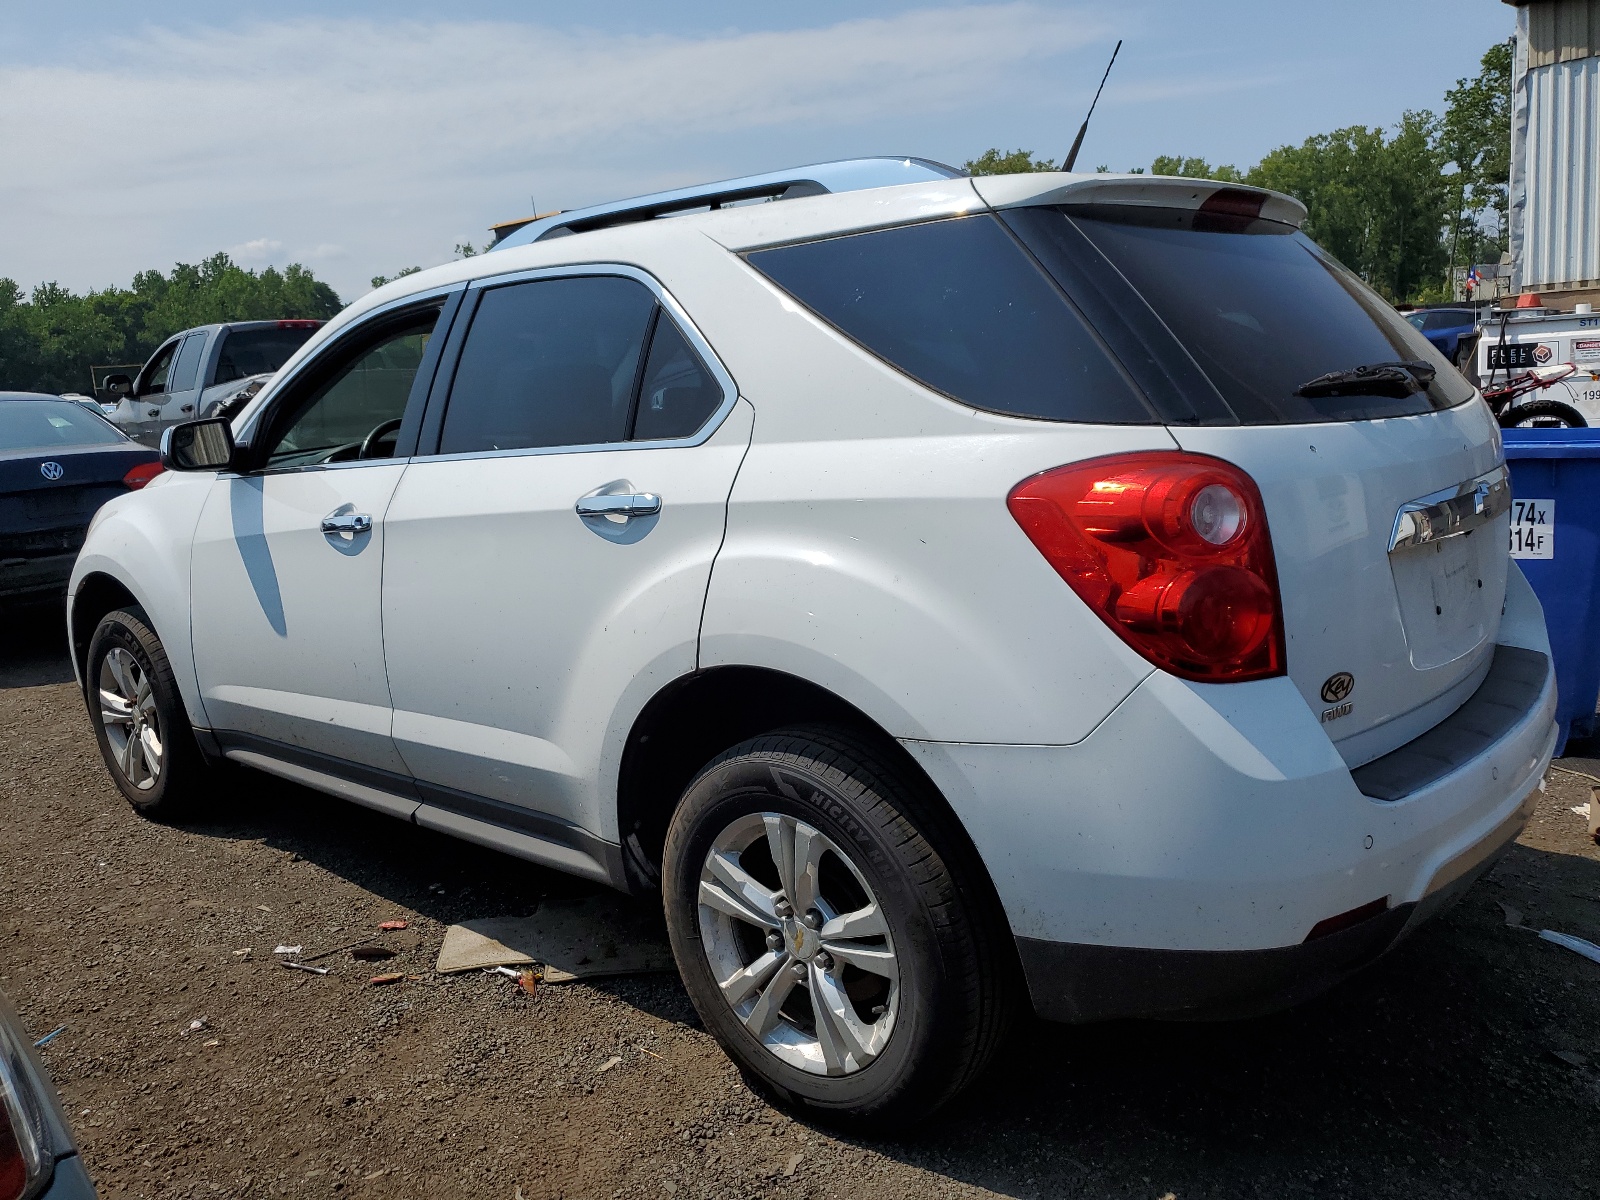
xmin=490 ymin=157 xmax=966 ymax=250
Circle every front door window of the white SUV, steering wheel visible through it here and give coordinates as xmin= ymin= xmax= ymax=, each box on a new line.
xmin=262 ymin=307 xmax=438 ymax=469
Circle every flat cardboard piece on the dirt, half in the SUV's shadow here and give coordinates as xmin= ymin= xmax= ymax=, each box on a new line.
xmin=434 ymin=896 xmax=675 ymax=984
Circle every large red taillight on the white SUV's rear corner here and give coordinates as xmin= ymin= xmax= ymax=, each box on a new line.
xmin=1006 ymin=451 xmax=1283 ymax=683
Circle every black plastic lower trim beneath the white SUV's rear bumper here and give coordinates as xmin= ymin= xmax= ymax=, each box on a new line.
xmin=1016 ymin=904 xmax=1416 ymax=1022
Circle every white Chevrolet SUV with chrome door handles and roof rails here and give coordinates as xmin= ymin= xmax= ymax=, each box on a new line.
xmin=69 ymin=167 xmax=1555 ymax=1122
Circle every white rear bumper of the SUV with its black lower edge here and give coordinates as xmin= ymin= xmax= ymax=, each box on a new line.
xmin=904 ymin=595 xmax=1557 ymax=1021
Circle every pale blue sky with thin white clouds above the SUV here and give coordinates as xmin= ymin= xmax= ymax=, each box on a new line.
xmin=0 ymin=0 xmax=1515 ymax=301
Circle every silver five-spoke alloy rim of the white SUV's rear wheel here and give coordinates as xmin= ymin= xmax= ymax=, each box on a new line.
xmin=699 ymin=813 xmax=901 ymax=1075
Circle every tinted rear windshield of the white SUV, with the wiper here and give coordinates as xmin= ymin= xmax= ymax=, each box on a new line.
xmin=1061 ymin=210 xmax=1472 ymax=424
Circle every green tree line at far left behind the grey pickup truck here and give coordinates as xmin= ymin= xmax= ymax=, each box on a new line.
xmin=0 ymin=254 xmax=344 ymax=392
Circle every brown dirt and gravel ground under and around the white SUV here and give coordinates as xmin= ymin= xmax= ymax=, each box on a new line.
xmin=0 ymin=616 xmax=1600 ymax=1200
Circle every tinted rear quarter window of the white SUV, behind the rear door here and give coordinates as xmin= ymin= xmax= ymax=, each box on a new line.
xmin=749 ymin=216 xmax=1152 ymax=422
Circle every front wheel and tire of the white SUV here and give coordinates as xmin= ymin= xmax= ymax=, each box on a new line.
xmin=83 ymin=606 xmax=210 ymax=821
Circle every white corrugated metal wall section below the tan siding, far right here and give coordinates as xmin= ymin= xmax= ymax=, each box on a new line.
xmin=1522 ymin=58 xmax=1600 ymax=290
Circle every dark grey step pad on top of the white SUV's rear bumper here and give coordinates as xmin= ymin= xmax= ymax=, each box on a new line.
xmin=1350 ymin=646 xmax=1550 ymax=800
